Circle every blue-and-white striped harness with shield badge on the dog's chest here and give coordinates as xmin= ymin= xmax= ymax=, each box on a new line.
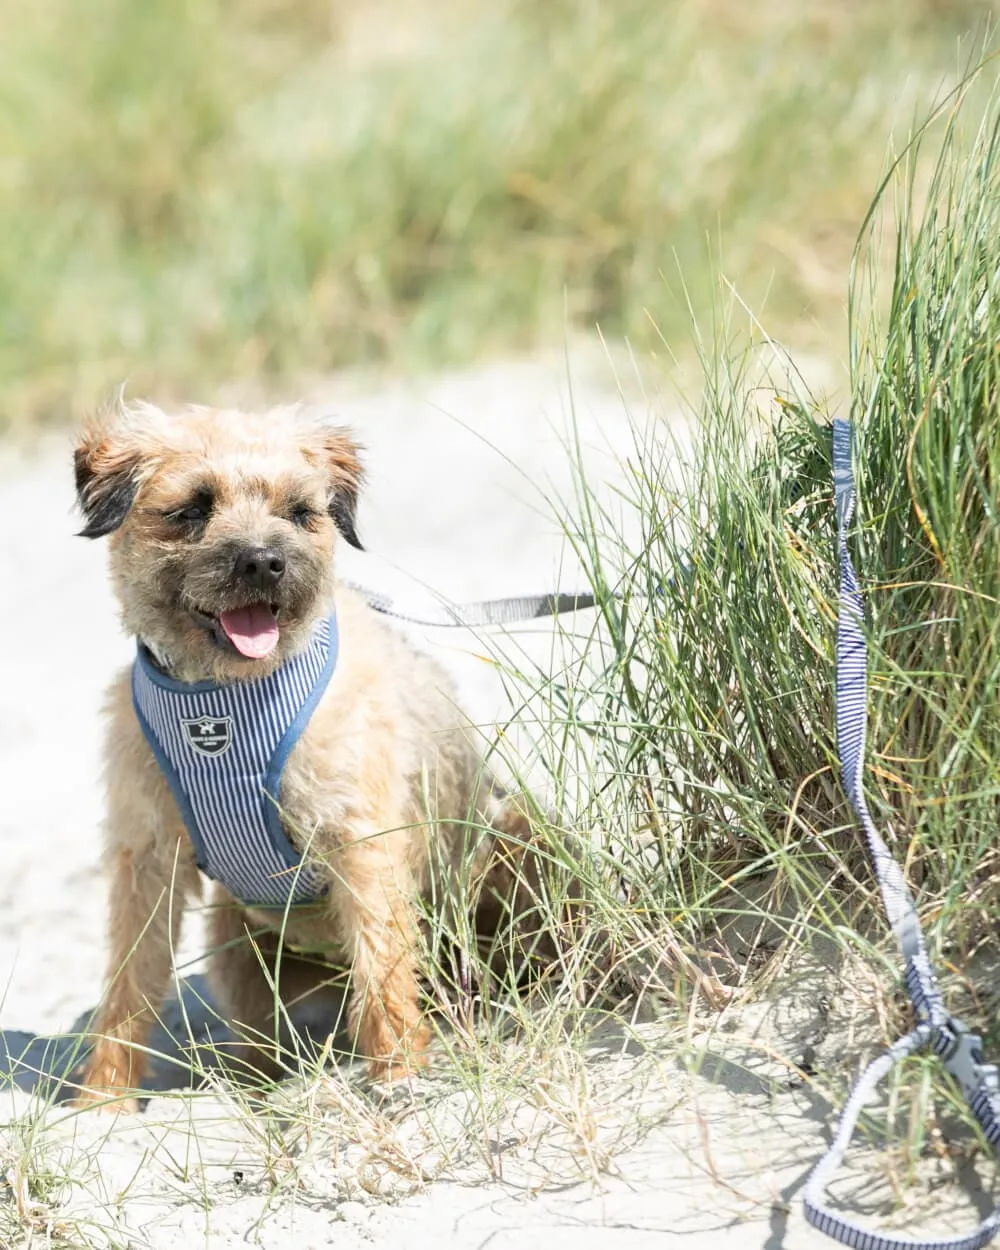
xmin=133 ymin=615 xmax=338 ymax=908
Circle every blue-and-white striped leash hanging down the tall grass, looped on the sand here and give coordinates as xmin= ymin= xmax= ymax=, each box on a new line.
xmin=803 ymin=421 xmax=1000 ymax=1250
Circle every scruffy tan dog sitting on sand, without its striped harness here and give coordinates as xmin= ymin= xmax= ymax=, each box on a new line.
xmin=76 ymin=404 xmax=542 ymax=1101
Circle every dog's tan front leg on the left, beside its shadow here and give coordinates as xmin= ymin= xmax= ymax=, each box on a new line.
xmin=76 ymin=836 xmax=198 ymax=1111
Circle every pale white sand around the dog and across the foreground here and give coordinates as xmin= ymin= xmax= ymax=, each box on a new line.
xmin=0 ymin=359 xmax=975 ymax=1250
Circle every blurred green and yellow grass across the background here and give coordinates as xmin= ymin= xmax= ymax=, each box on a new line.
xmin=0 ymin=0 xmax=994 ymax=428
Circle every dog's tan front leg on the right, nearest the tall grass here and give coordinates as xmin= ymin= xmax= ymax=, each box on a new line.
xmin=331 ymin=829 xmax=430 ymax=1081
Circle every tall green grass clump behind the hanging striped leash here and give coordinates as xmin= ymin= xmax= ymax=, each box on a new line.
xmin=507 ymin=61 xmax=1000 ymax=1033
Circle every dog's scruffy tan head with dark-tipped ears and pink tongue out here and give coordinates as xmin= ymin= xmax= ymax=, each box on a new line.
xmin=75 ymin=405 xmax=361 ymax=681
